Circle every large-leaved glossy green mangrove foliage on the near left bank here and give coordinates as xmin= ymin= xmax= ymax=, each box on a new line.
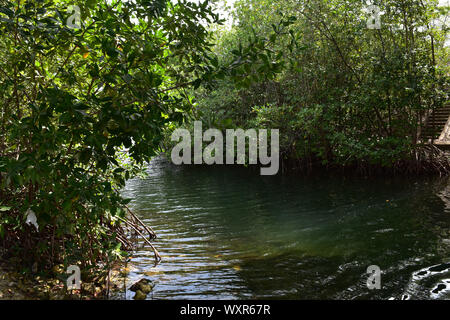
xmin=0 ymin=0 xmax=227 ymax=276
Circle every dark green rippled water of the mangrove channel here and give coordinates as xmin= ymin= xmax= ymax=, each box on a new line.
xmin=119 ymin=159 xmax=450 ymax=299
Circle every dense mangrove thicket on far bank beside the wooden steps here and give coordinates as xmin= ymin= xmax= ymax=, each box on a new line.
xmin=185 ymin=0 xmax=449 ymax=172
